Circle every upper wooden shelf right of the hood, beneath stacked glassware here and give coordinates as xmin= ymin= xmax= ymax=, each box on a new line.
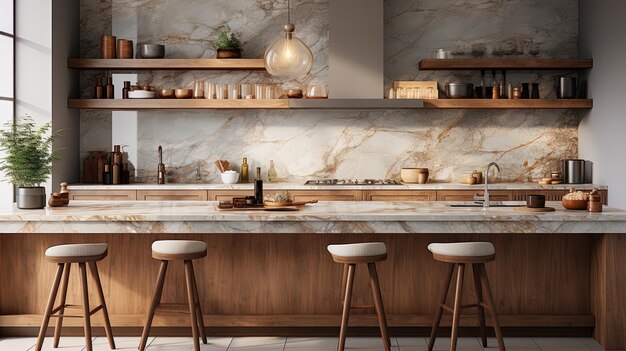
xmin=419 ymin=58 xmax=593 ymax=71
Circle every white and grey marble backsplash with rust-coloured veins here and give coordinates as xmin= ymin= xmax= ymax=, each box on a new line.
xmin=81 ymin=0 xmax=579 ymax=182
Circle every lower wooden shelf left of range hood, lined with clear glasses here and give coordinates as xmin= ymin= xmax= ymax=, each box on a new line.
xmin=67 ymin=99 xmax=289 ymax=110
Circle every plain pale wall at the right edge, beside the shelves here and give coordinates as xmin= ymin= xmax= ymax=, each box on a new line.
xmin=579 ymin=0 xmax=626 ymax=209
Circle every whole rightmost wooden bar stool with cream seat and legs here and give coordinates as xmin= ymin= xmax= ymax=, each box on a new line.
xmin=428 ymin=242 xmax=505 ymax=351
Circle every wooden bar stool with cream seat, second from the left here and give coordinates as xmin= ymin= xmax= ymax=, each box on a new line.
xmin=139 ymin=240 xmax=207 ymax=351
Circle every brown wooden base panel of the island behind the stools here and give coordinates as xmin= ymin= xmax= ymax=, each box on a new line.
xmin=0 ymin=233 xmax=626 ymax=349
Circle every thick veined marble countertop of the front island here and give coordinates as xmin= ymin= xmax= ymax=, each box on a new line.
xmin=0 ymin=201 xmax=626 ymax=233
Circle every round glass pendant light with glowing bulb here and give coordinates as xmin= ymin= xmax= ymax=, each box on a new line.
xmin=265 ymin=0 xmax=313 ymax=77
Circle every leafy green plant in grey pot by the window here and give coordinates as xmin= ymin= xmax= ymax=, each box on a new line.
xmin=0 ymin=116 xmax=56 ymax=209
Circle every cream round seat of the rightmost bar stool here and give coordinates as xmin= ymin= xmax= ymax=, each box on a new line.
xmin=428 ymin=242 xmax=496 ymax=263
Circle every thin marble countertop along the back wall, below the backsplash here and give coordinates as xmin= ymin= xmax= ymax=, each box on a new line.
xmin=68 ymin=182 xmax=608 ymax=190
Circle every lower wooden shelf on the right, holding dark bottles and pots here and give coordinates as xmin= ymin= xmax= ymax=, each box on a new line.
xmin=424 ymin=99 xmax=593 ymax=109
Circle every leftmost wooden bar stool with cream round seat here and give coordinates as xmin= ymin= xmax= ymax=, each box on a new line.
xmin=35 ymin=243 xmax=115 ymax=351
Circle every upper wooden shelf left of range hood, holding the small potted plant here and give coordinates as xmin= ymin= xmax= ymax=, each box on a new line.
xmin=67 ymin=59 xmax=265 ymax=70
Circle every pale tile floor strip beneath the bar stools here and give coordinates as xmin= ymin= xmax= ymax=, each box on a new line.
xmin=0 ymin=337 xmax=604 ymax=351
